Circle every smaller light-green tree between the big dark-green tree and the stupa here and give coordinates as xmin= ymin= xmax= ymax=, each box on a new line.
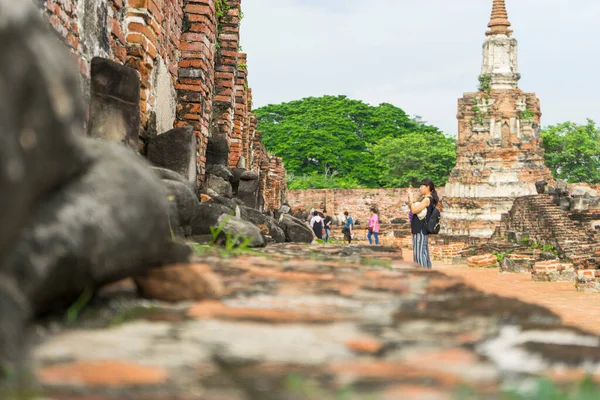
xmin=373 ymin=132 xmax=456 ymax=187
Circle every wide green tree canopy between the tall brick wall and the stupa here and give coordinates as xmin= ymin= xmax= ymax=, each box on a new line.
xmin=255 ymin=96 xmax=456 ymax=189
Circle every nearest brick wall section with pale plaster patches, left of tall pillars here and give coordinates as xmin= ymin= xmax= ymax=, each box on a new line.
xmin=40 ymin=0 xmax=184 ymax=143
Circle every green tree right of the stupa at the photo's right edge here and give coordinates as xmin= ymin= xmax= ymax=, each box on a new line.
xmin=542 ymin=119 xmax=600 ymax=183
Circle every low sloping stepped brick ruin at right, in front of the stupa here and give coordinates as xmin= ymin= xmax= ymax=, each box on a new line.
xmin=494 ymin=186 xmax=600 ymax=292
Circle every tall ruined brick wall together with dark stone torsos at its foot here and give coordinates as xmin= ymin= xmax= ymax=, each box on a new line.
xmin=35 ymin=0 xmax=286 ymax=209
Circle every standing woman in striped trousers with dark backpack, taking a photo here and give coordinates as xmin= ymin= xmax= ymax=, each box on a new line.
xmin=408 ymin=179 xmax=440 ymax=268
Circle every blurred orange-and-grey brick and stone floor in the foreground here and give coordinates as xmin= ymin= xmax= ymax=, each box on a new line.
xmin=15 ymin=244 xmax=600 ymax=400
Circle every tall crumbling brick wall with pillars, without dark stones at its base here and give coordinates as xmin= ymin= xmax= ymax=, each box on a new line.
xmin=36 ymin=0 xmax=285 ymax=208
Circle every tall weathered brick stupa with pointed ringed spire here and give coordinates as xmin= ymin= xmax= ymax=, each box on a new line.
xmin=443 ymin=0 xmax=552 ymax=237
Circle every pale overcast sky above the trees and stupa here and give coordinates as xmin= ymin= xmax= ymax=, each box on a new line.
xmin=241 ymin=0 xmax=600 ymax=135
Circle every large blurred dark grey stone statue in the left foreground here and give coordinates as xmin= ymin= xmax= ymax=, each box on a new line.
xmin=0 ymin=0 xmax=189 ymax=384
